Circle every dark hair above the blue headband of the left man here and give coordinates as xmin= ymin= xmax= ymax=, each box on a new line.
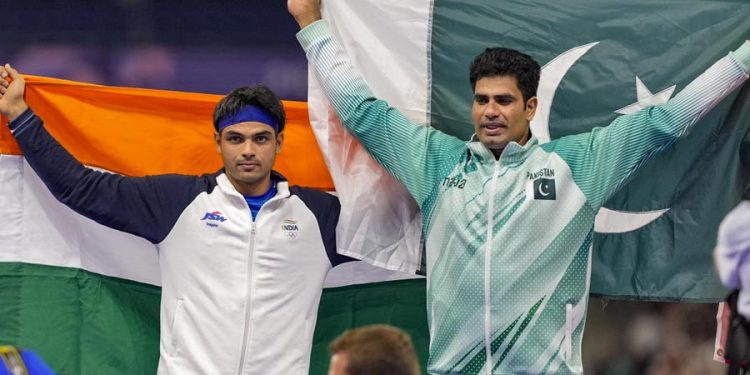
xmin=214 ymin=85 xmax=286 ymax=133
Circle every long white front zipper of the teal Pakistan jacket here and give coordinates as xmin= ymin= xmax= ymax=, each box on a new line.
xmin=484 ymin=160 xmax=500 ymax=375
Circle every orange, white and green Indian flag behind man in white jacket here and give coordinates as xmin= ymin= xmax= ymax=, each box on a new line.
xmin=0 ymin=77 xmax=428 ymax=375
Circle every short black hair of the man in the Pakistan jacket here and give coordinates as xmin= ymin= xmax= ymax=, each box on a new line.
xmin=469 ymin=47 xmax=542 ymax=102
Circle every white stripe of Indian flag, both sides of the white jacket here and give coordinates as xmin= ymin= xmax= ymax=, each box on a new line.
xmin=0 ymin=155 xmax=424 ymax=287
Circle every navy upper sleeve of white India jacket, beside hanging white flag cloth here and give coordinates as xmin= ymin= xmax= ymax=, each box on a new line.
xmin=289 ymin=186 xmax=355 ymax=267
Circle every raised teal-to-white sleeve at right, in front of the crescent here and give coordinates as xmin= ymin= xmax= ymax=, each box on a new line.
xmin=543 ymin=41 xmax=750 ymax=212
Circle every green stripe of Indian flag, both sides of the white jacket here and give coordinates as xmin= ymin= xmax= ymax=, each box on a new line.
xmin=0 ymin=262 xmax=429 ymax=375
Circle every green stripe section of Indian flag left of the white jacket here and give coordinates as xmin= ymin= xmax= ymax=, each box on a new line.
xmin=0 ymin=263 xmax=161 ymax=375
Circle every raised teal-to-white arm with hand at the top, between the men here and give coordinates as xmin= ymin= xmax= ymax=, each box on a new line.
xmin=288 ymin=0 xmax=464 ymax=205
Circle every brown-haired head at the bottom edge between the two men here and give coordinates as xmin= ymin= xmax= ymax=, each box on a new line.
xmin=330 ymin=324 xmax=420 ymax=375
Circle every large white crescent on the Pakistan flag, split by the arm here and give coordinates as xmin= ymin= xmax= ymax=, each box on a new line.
xmin=529 ymin=42 xmax=669 ymax=233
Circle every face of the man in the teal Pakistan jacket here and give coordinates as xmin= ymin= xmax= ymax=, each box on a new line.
xmin=471 ymin=76 xmax=537 ymax=156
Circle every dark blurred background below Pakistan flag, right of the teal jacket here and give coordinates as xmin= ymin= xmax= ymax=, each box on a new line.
xmin=583 ymin=298 xmax=725 ymax=375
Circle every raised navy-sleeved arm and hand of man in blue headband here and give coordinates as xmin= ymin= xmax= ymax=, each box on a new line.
xmin=0 ymin=65 xmax=200 ymax=243
